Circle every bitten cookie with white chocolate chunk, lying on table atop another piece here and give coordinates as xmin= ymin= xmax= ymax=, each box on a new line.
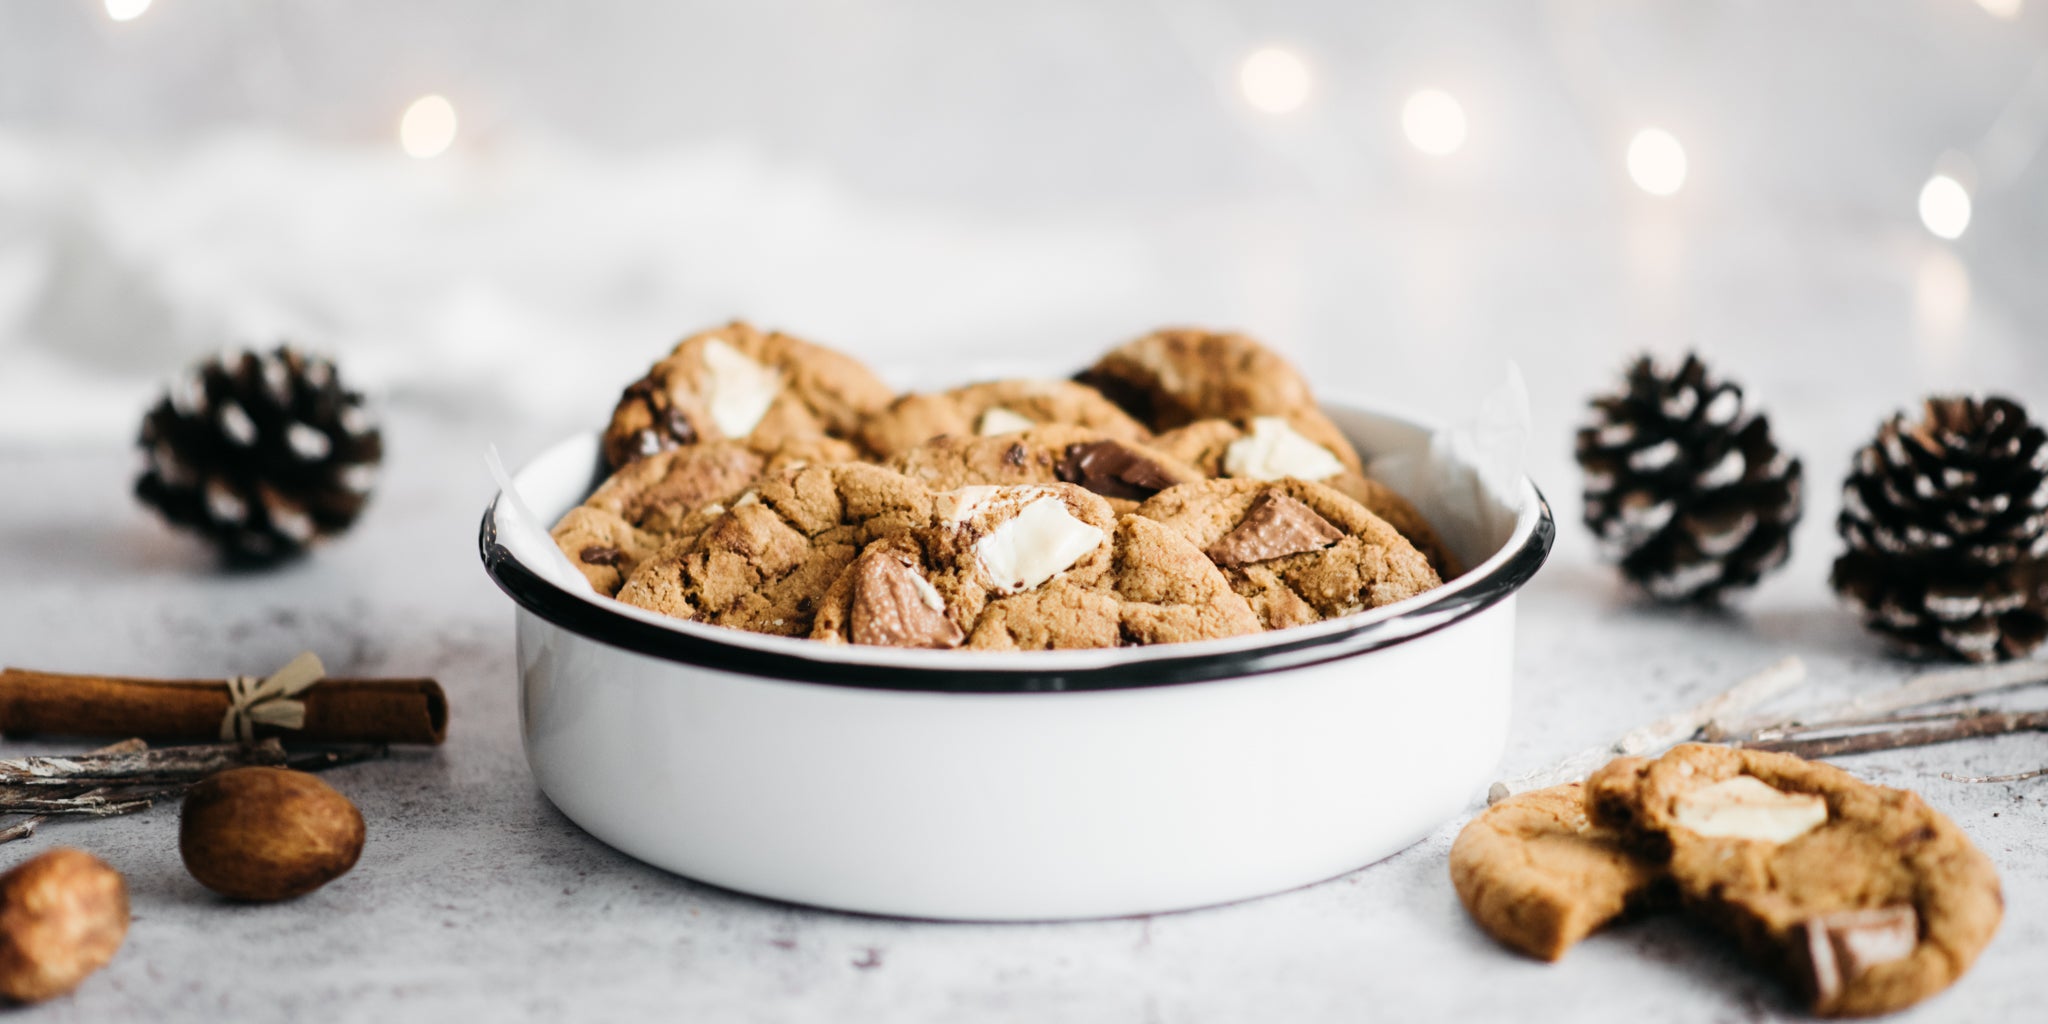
xmin=1585 ymin=743 xmax=2003 ymax=1016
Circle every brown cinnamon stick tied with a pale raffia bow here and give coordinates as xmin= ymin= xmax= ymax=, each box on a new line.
xmin=0 ymin=668 xmax=449 ymax=743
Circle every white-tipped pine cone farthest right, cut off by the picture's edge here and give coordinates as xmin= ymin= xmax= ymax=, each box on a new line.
xmin=1833 ymin=397 xmax=2048 ymax=662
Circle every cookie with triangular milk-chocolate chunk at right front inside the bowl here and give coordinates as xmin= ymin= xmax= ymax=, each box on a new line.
xmin=1137 ymin=479 xmax=1442 ymax=629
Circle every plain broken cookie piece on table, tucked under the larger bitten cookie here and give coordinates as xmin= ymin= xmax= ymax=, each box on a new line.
xmin=1450 ymin=782 xmax=1671 ymax=961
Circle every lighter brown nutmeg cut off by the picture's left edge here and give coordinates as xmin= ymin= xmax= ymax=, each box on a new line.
xmin=0 ymin=848 xmax=127 ymax=1004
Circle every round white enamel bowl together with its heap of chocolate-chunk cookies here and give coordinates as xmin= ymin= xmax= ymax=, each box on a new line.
xmin=481 ymin=324 xmax=1554 ymax=920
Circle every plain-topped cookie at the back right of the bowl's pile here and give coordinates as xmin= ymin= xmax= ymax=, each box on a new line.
xmin=1075 ymin=328 xmax=1315 ymax=430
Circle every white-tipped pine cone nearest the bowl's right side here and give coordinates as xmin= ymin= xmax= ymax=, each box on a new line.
xmin=1579 ymin=356 xmax=1800 ymax=604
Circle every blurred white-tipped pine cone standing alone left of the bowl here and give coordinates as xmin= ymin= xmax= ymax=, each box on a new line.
xmin=135 ymin=346 xmax=383 ymax=563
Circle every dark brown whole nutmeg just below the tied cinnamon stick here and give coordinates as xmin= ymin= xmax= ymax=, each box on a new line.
xmin=178 ymin=768 xmax=362 ymax=901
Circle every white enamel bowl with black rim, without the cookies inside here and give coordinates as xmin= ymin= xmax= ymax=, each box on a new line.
xmin=481 ymin=408 xmax=1554 ymax=920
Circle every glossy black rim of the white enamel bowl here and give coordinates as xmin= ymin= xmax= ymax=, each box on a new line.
xmin=479 ymin=483 xmax=1556 ymax=692
